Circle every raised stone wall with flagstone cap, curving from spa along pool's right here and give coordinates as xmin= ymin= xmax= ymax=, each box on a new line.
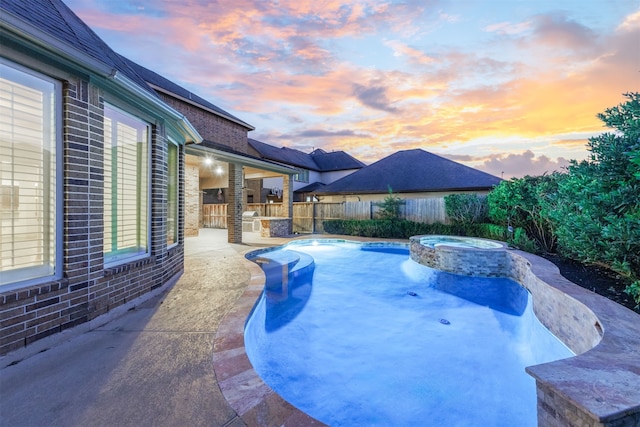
xmin=410 ymin=236 xmax=640 ymax=427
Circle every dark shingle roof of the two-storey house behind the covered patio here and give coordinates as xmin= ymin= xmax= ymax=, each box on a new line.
xmin=249 ymin=138 xmax=365 ymax=172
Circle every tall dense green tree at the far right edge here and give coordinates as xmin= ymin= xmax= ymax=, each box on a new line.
xmin=548 ymin=93 xmax=640 ymax=303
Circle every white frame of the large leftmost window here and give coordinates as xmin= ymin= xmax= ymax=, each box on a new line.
xmin=0 ymin=57 xmax=64 ymax=292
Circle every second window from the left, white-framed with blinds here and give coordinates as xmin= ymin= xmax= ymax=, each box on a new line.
xmin=104 ymin=104 xmax=150 ymax=264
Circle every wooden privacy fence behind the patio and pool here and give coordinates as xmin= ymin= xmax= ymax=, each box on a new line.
xmin=202 ymin=197 xmax=447 ymax=233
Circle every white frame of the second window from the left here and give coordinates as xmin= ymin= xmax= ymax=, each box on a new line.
xmin=103 ymin=101 xmax=153 ymax=268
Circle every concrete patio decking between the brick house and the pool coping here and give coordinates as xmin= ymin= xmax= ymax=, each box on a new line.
xmin=0 ymin=229 xmax=287 ymax=427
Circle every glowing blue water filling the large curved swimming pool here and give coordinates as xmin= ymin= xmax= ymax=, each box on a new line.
xmin=245 ymin=243 xmax=573 ymax=426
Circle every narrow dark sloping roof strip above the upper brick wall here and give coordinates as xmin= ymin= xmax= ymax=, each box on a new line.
xmin=121 ymin=56 xmax=255 ymax=130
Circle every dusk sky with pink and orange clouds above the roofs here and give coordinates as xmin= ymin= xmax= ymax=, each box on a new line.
xmin=65 ymin=0 xmax=640 ymax=178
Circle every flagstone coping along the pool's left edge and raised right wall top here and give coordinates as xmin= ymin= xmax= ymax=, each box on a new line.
xmin=213 ymin=236 xmax=640 ymax=426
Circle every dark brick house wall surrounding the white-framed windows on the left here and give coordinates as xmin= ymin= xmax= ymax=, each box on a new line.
xmin=0 ymin=73 xmax=184 ymax=363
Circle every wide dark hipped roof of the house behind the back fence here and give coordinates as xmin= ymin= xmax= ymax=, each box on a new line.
xmin=318 ymin=149 xmax=501 ymax=194
